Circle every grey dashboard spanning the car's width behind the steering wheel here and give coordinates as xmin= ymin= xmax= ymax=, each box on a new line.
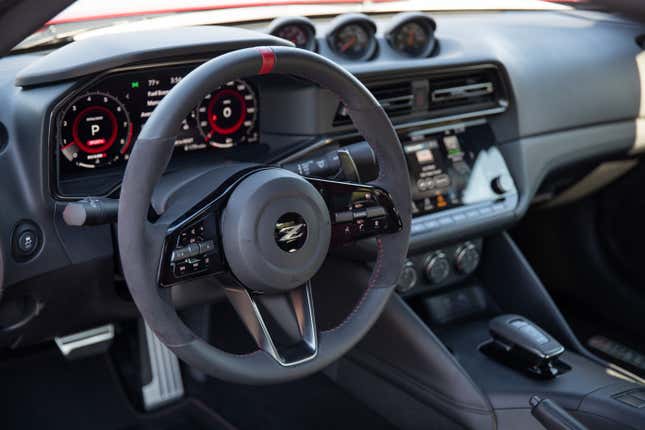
xmin=0 ymin=7 xmax=645 ymax=342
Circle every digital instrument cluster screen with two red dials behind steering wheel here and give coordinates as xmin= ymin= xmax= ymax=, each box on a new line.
xmin=56 ymin=65 xmax=258 ymax=173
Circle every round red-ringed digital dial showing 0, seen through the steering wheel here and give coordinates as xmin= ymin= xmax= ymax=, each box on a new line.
xmin=197 ymin=81 xmax=257 ymax=148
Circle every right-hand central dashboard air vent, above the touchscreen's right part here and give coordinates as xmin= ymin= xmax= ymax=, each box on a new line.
xmin=429 ymin=67 xmax=505 ymax=116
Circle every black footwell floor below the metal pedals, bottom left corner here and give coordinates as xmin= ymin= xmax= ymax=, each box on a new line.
xmin=0 ymin=348 xmax=233 ymax=430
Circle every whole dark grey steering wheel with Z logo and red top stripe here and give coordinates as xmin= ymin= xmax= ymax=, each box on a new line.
xmin=118 ymin=47 xmax=411 ymax=384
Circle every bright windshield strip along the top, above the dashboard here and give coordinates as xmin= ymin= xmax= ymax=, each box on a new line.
xmin=13 ymin=0 xmax=585 ymax=52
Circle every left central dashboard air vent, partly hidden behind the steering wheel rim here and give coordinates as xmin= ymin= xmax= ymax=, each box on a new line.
xmin=334 ymin=81 xmax=414 ymax=126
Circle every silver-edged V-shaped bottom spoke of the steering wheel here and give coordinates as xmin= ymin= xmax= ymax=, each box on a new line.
xmin=220 ymin=274 xmax=318 ymax=366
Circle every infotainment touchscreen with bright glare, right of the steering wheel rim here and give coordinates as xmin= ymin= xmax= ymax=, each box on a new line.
xmin=403 ymin=124 xmax=499 ymax=215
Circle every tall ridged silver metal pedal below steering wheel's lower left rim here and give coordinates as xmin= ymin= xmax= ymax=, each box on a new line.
xmin=141 ymin=323 xmax=184 ymax=411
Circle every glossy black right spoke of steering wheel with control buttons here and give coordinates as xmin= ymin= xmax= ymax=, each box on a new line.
xmin=307 ymin=178 xmax=402 ymax=247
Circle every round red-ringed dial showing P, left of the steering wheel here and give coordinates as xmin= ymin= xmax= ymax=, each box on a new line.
xmin=59 ymin=92 xmax=132 ymax=168
